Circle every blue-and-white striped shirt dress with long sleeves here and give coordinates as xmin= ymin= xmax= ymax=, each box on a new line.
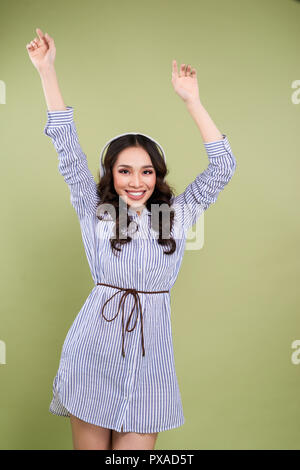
xmin=44 ymin=106 xmax=236 ymax=433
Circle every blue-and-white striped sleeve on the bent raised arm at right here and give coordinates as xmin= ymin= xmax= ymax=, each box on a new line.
xmin=172 ymin=134 xmax=236 ymax=231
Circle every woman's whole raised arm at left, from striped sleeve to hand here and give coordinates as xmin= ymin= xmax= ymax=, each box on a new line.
xmin=26 ymin=28 xmax=100 ymax=220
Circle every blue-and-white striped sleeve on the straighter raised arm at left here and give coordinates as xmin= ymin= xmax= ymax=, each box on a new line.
xmin=44 ymin=106 xmax=100 ymax=219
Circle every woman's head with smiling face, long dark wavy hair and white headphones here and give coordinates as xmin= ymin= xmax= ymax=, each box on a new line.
xmin=97 ymin=133 xmax=176 ymax=255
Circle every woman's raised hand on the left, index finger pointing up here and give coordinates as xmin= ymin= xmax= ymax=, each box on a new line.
xmin=26 ymin=28 xmax=56 ymax=72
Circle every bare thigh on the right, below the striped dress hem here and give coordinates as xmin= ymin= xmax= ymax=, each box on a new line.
xmin=112 ymin=429 xmax=158 ymax=450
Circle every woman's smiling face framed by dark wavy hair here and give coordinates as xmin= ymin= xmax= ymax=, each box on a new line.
xmin=112 ymin=147 xmax=156 ymax=214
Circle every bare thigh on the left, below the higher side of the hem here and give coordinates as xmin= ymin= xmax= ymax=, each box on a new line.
xmin=70 ymin=414 xmax=112 ymax=450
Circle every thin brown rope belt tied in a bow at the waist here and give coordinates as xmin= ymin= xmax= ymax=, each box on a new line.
xmin=97 ymin=282 xmax=169 ymax=357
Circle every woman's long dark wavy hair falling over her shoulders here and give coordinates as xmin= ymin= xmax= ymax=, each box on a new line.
xmin=97 ymin=134 xmax=176 ymax=255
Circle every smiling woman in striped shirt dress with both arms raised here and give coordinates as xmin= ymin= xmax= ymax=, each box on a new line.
xmin=26 ymin=28 xmax=236 ymax=450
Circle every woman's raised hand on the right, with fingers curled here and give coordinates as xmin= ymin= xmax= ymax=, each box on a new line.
xmin=172 ymin=60 xmax=200 ymax=104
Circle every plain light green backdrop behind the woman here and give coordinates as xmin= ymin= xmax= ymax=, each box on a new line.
xmin=0 ymin=0 xmax=300 ymax=449
